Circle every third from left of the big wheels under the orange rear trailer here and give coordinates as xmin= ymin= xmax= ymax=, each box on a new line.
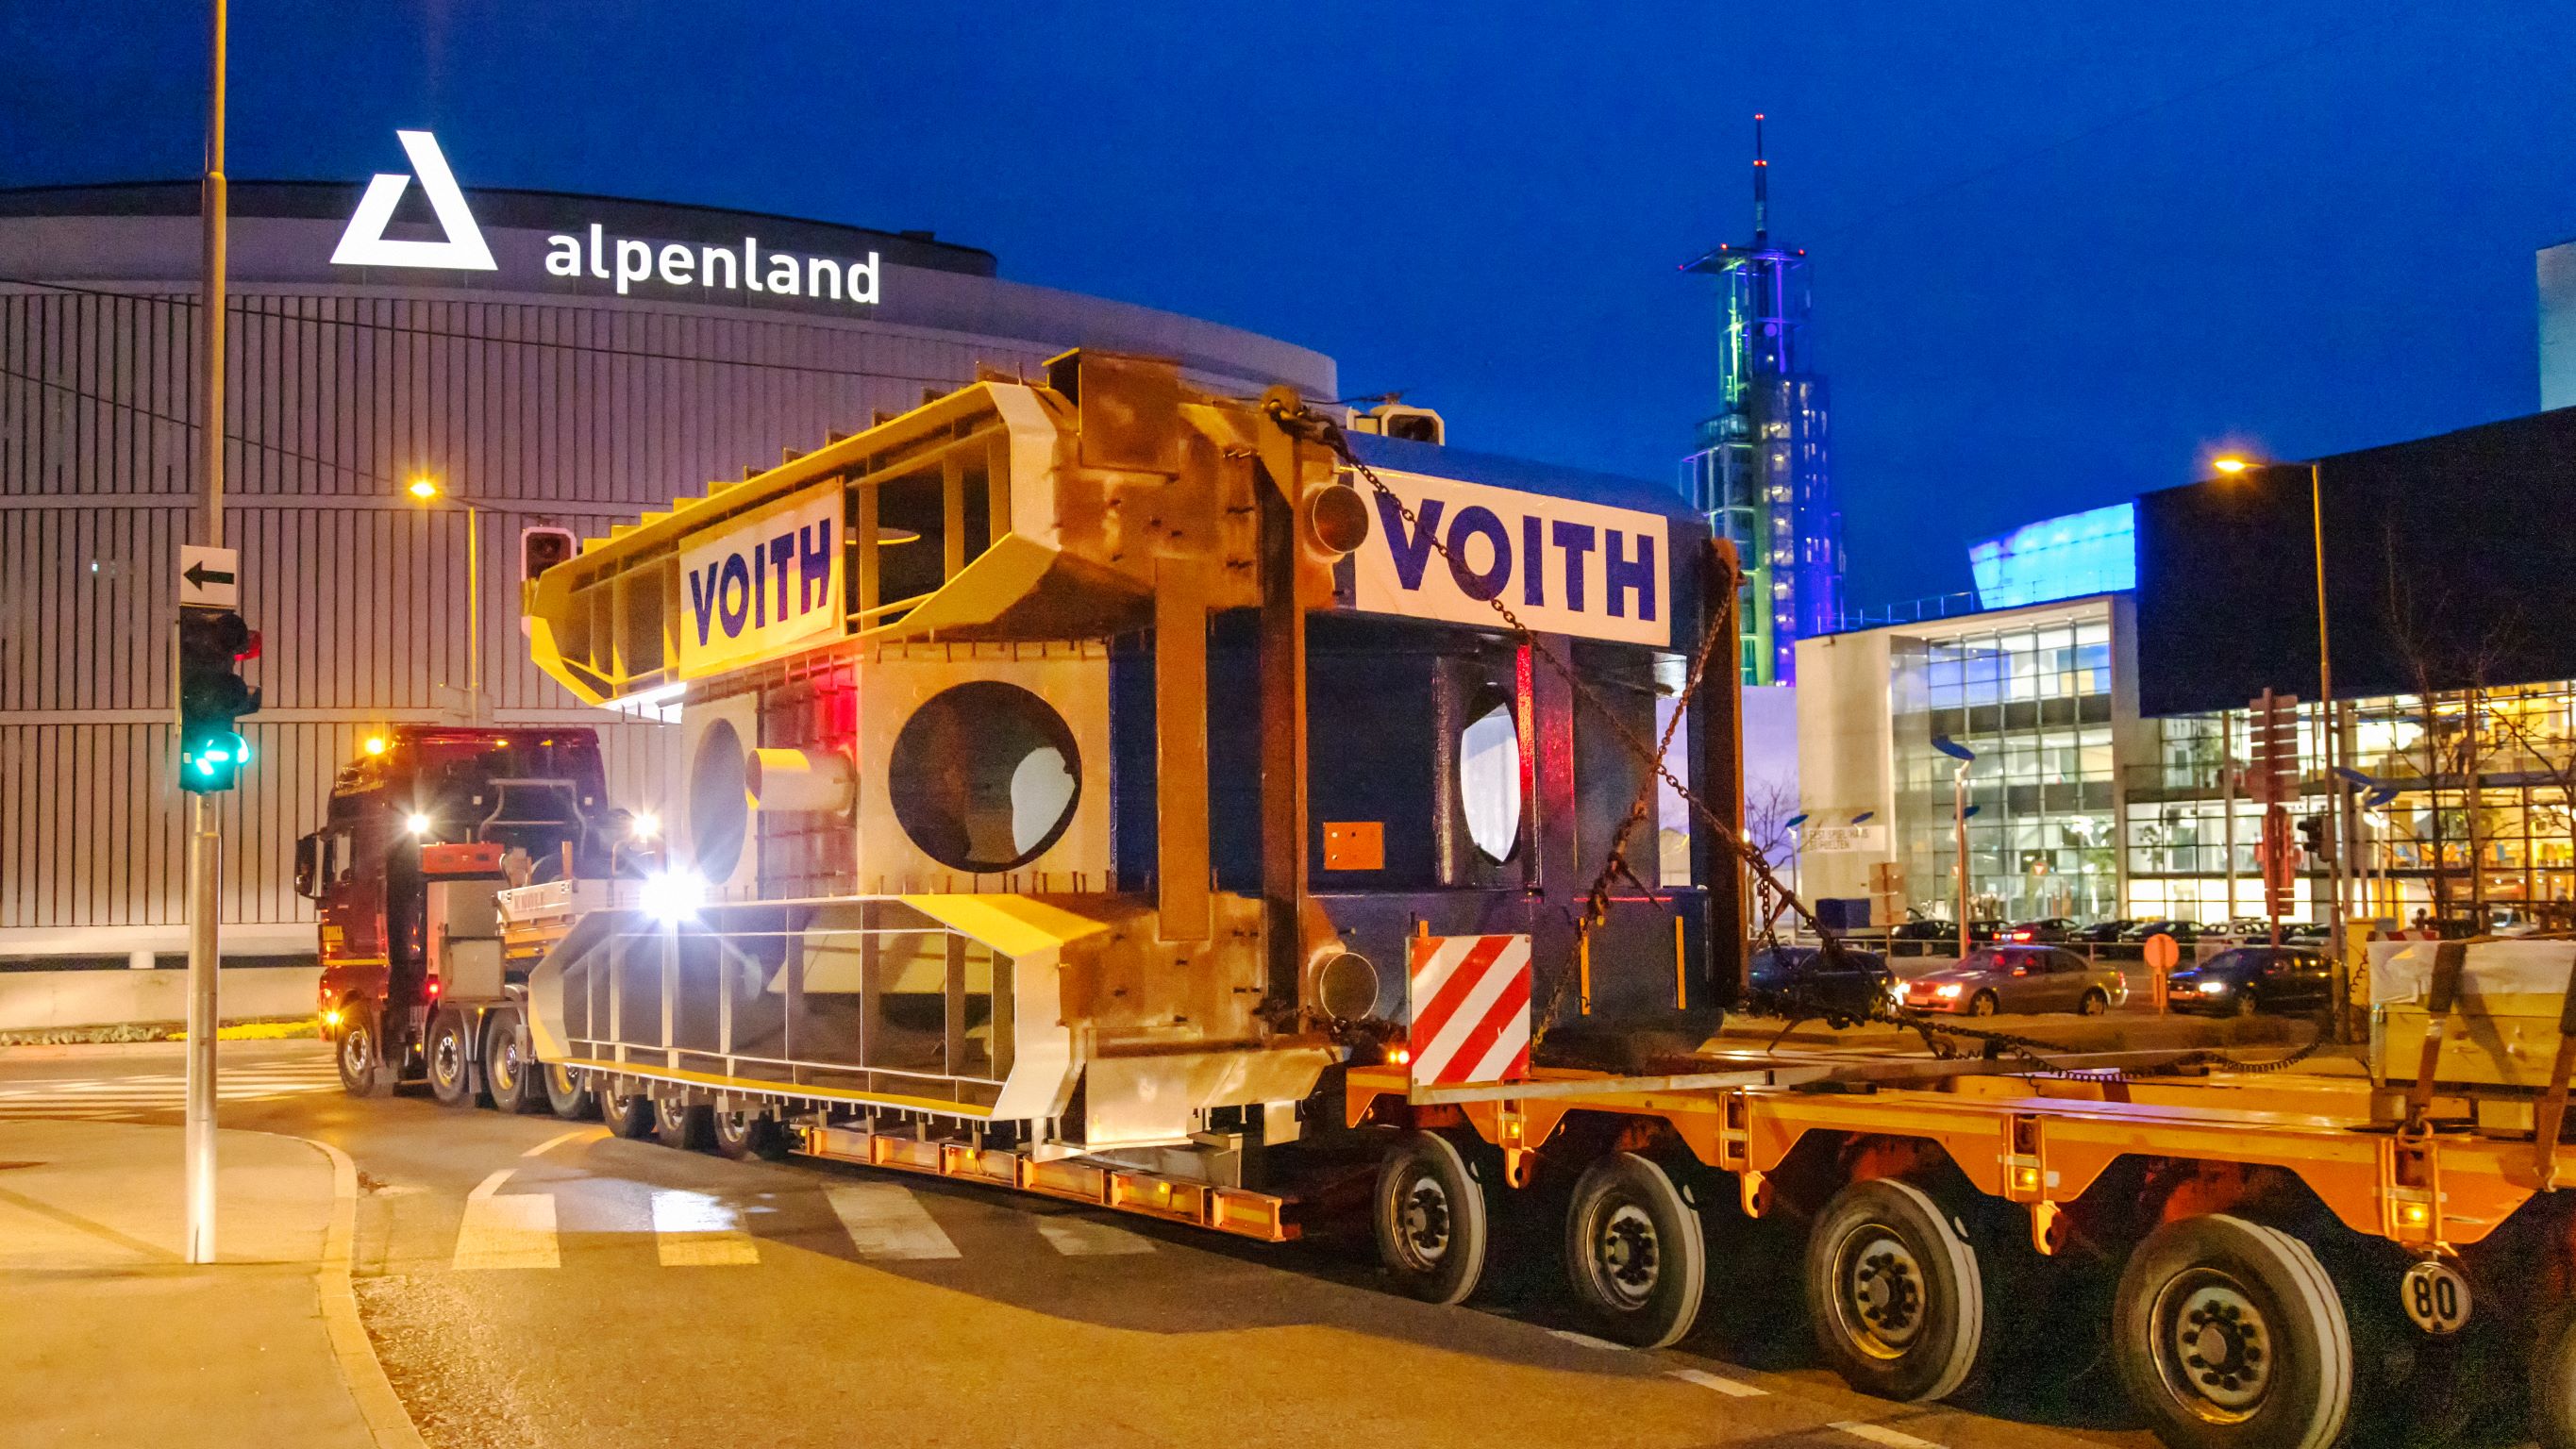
xmin=1803 ymin=1179 xmax=1986 ymax=1403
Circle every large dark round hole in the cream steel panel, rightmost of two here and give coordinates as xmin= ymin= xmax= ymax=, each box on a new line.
xmin=886 ymin=679 xmax=1082 ymax=875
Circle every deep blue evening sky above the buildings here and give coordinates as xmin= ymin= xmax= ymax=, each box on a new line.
xmin=0 ymin=0 xmax=2576 ymax=602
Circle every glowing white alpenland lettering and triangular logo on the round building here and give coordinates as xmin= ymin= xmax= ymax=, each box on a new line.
xmin=329 ymin=131 xmax=878 ymax=307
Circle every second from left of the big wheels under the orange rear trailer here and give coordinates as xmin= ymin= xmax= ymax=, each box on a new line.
xmin=1566 ymin=1153 xmax=1708 ymax=1349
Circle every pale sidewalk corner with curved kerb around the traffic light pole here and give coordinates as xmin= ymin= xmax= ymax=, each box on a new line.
xmin=0 ymin=1123 xmax=420 ymax=1449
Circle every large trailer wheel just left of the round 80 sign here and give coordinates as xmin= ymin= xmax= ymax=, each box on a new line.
xmin=2113 ymin=1212 xmax=2351 ymax=1449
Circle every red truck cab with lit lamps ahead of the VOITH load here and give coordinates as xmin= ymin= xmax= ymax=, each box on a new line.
xmin=296 ymin=725 xmax=623 ymax=1096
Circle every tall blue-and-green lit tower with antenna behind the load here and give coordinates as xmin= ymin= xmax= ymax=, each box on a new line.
xmin=1682 ymin=116 xmax=1842 ymax=685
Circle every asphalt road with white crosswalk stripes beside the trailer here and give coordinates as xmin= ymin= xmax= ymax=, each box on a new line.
xmin=0 ymin=1042 xmax=2151 ymax=1449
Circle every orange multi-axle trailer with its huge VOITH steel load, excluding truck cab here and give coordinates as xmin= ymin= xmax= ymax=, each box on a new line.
xmin=322 ymin=353 xmax=2576 ymax=1449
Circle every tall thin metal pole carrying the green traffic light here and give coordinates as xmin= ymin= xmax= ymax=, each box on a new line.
xmin=186 ymin=0 xmax=229 ymax=1264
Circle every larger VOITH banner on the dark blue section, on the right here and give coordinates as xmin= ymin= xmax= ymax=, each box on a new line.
xmin=1355 ymin=469 xmax=1672 ymax=649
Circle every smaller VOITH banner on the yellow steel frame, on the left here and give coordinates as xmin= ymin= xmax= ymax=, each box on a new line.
xmin=680 ymin=478 xmax=843 ymax=679
